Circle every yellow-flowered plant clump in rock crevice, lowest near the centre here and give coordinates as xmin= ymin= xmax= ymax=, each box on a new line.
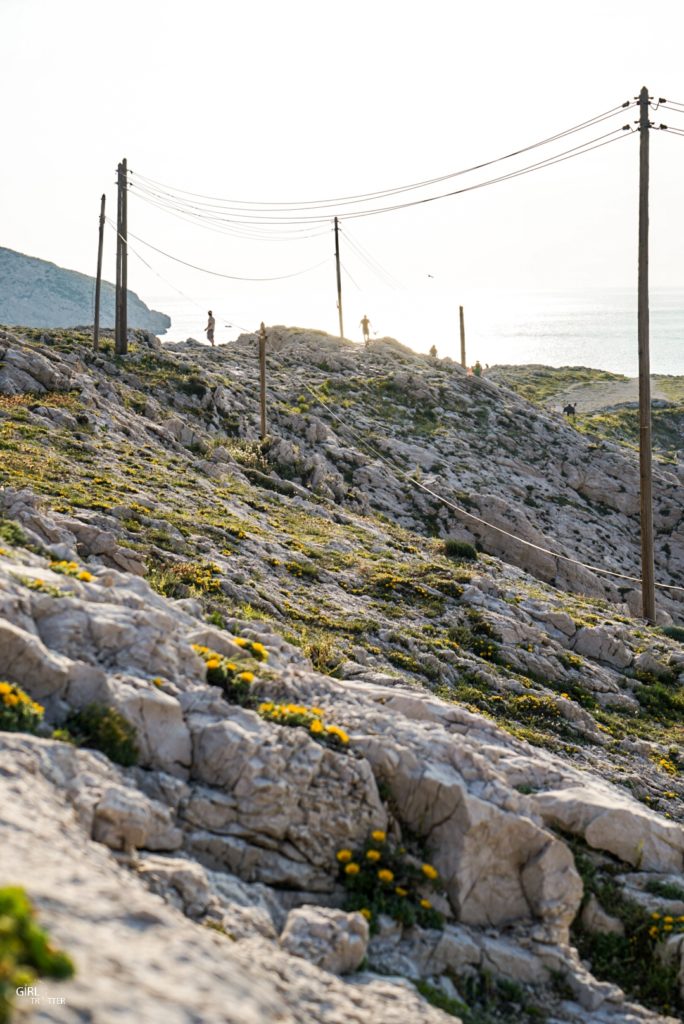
xmin=336 ymin=828 xmax=444 ymax=933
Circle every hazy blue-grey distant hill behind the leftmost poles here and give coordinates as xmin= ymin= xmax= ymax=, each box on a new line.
xmin=0 ymin=247 xmax=171 ymax=335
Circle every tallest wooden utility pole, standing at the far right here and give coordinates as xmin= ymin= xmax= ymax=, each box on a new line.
xmin=637 ymin=86 xmax=655 ymax=623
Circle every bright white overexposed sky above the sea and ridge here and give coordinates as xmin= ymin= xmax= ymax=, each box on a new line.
xmin=0 ymin=0 xmax=684 ymax=362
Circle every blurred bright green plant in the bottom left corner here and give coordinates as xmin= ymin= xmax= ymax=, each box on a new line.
xmin=0 ymin=886 xmax=75 ymax=1024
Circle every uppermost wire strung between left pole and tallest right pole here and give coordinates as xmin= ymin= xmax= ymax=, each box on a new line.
xmin=126 ymin=100 xmax=636 ymax=212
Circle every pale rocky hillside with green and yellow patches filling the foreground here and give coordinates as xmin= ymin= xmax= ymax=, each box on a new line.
xmin=0 ymin=329 xmax=684 ymax=1024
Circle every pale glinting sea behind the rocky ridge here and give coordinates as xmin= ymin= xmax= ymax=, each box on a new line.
xmin=144 ymin=287 xmax=684 ymax=377
